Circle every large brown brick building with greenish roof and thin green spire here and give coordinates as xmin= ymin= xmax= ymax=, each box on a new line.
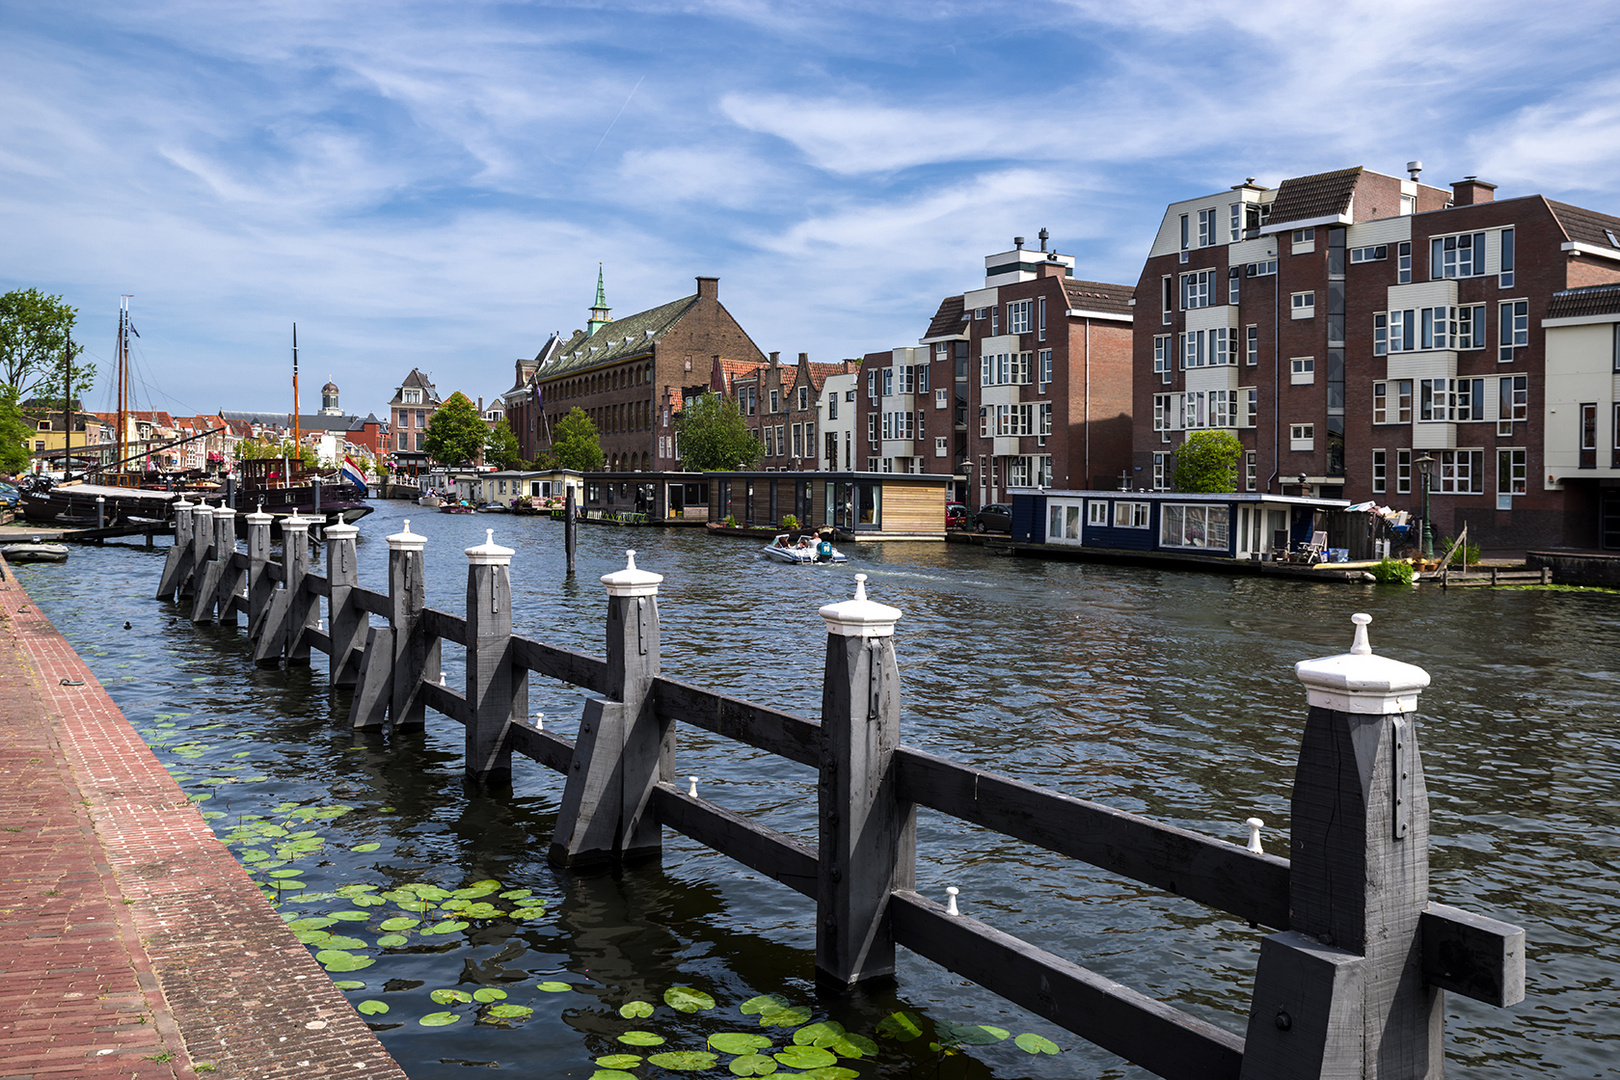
xmin=522 ymin=274 xmax=765 ymax=473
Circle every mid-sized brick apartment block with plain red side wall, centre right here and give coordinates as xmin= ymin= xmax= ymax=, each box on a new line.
xmin=855 ymin=230 xmax=1132 ymax=507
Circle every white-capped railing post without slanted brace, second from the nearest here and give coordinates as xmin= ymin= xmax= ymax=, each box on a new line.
xmin=815 ymin=573 xmax=917 ymax=986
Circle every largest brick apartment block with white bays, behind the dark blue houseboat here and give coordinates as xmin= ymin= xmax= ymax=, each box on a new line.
xmin=1132 ymin=162 xmax=1620 ymax=547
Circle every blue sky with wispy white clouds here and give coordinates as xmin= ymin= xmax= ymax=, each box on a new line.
xmin=0 ymin=0 xmax=1620 ymax=415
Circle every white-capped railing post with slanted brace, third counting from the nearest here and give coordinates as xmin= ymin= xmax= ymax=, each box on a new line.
xmin=551 ymin=551 xmax=676 ymax=866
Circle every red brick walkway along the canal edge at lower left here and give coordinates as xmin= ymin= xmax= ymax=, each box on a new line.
xmin=0 ymin=560 xmax=405 ymax=1080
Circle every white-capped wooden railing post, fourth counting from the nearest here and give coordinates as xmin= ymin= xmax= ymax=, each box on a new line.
xmin=463 ymin=529 xmax=528 ymax=784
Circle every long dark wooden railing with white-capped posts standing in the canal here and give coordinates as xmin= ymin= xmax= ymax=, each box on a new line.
xmin=157 ymin=502 xmax=1524 ymax=1080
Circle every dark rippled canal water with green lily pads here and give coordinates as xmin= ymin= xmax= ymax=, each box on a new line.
xmin=16 ymin=502 xmax=1620 ymax=1080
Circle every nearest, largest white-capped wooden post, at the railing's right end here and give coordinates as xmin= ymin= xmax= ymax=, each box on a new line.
xmin=1243 ymin=614 xmax=1445 ymax=1080
